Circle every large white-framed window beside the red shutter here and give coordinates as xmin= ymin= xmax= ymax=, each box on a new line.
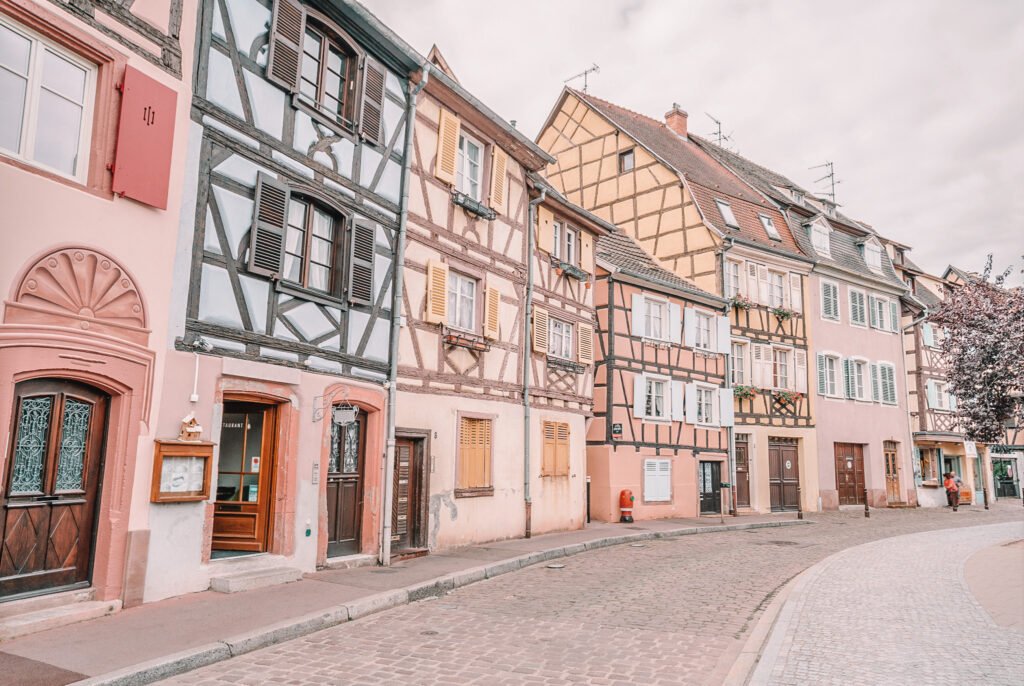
xmin=0 ymin=18 xmax=96 ymax=181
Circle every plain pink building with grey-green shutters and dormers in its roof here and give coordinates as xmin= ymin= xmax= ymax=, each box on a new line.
xmin=693 ymin=141 xmax=916 ymax=510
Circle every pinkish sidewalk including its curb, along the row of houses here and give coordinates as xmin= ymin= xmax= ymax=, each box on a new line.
xmin=0 ymin=513 xmax=806 ymax=686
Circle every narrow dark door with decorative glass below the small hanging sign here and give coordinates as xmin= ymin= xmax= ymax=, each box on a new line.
xmin=327 ymin=412 xmax=367 ymax=557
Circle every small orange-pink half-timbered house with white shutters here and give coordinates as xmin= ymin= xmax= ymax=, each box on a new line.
xmin=587 ymin=231 xmax=733 ymax=521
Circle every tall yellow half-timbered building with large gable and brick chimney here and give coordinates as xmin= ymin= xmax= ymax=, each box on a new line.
xmin=538 ymin=88 xmax=818 ymax=512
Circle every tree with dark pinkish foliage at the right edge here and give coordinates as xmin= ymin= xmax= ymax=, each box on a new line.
xmin=929 ymin=255 xmax=1024 ymax=443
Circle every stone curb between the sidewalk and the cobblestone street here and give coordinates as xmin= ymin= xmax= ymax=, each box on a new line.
xmin=75 ymin=519 xmax=812 ymax=686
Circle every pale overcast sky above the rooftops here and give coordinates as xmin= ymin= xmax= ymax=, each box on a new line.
xmin=365 ymin=0 xmax=1024 ymax=284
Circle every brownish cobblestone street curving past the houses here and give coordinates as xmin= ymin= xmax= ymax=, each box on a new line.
xmin=163 ymin=504 xmax=1024 ymax=686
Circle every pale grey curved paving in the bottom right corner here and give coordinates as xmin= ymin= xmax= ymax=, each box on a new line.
xmin=749 ymin=521 xmax=1024 ymax=686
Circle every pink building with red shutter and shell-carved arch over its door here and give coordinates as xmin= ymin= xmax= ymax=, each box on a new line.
xmin=0 ymin=0 xmax=195 ymax=630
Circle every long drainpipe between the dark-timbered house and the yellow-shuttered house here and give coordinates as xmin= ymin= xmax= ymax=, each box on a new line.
xmin=379 ymin=61 xmax=430 ymax=566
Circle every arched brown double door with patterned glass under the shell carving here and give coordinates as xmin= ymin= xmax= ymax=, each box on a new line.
xmin=0 ymin=379 xmax=109 ymax=600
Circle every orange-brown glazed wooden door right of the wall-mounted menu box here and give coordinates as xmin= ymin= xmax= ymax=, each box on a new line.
xmin=213 ymin=400 xmax=278 ymax=553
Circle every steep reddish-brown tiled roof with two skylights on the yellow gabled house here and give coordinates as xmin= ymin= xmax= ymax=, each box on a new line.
xmin=566 ymin=88 xmax=803 ymax=261
